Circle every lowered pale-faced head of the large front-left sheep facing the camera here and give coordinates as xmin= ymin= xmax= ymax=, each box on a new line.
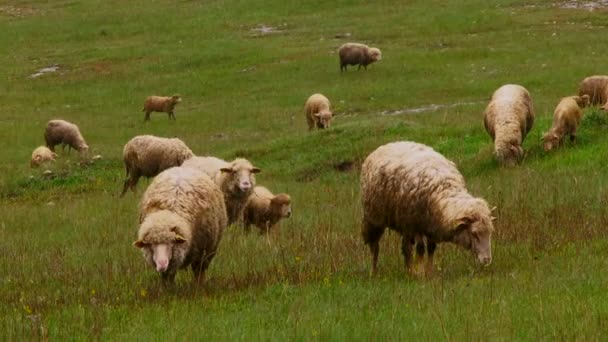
xmin=133 ymin=211 xmax=189 ymax=273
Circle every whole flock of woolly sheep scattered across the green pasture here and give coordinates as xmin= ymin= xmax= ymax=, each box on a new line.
xmin=26 ymin=43 xmax=608 ymax=282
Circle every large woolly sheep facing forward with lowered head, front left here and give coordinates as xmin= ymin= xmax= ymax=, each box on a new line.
xmin=133 ymin=167 xmax=228 ymax=284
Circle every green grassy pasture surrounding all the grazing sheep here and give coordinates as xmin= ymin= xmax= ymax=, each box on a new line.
xmin=0 ymin=0 xmax=608 ymax=340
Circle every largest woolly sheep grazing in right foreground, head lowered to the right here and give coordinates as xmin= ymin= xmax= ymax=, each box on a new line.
xmin=361 ymin=141 xmax=494 ymax=274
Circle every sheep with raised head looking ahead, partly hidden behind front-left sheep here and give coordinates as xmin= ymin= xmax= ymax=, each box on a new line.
xmin=182 ymin=157 xmax=261 ymax=225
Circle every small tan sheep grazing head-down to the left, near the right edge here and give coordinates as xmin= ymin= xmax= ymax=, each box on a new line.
xmin=542 ymin=95 xmax=590 ymax=152
